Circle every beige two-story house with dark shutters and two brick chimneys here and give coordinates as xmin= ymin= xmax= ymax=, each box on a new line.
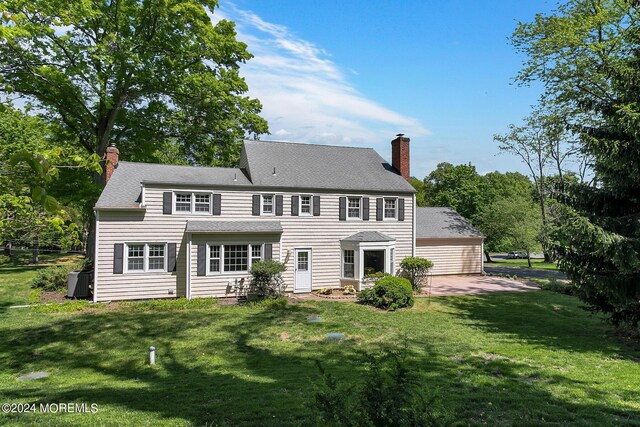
xmin=94 ymin=135 xmax=482 ymax=301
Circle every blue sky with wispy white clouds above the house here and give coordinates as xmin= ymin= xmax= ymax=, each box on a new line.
xmin=214 ymin=0 xmax=555 ymax=178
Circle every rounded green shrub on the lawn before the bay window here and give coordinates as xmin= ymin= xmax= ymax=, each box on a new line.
xmin=357 ymin=276 xmax=413 ymax=310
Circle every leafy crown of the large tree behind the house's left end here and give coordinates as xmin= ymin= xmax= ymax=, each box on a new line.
xmin=0 ymin=0 xmax=267 ymax=171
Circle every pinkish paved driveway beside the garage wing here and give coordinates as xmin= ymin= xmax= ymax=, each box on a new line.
xmin=424 ymin=276 xmax=539 ymax=296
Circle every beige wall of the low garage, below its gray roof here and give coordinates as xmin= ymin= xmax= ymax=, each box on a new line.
xmin=416 ymin=239 xmax=482 ymax=275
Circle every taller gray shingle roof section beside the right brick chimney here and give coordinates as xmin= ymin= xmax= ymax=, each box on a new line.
xmin=241 ymin=141 xmax=415 ymax=193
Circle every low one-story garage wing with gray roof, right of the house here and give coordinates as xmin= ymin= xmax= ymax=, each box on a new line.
xmin=416 ymin=207 xmax=483 ymax=275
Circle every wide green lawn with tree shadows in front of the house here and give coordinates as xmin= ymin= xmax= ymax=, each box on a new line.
xmin=0 ymin=270 xmax=640 ymax=426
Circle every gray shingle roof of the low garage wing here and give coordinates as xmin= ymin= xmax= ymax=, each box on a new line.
xmin=416 ymin=208 xmax=483 ymax=239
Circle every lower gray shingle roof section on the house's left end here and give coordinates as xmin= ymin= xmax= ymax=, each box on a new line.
xmin=96 ymin=161 xmax=251 ymax=208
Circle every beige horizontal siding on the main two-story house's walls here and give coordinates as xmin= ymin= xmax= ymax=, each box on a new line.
xmin=97 ymin=185 xmax=414 ymax=301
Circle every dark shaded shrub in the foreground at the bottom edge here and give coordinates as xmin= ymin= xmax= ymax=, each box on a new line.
xmin=309 ymin=344 xmax=445 ymax=426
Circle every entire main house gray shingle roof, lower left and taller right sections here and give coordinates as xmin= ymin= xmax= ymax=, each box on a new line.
xmin=96 ymin=141 xmax=415 ymax=208
